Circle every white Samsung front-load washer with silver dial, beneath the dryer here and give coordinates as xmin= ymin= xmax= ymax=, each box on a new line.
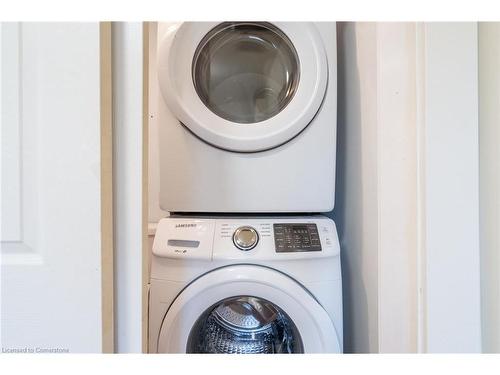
xmin=149 ymin=215 xmax=342 ymax=353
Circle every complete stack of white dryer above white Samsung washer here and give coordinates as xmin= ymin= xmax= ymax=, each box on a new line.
xmin=149 ymin=22 xmax=342 ymax=353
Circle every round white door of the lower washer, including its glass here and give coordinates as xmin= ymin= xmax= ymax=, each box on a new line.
xmin=158 ymin=265 xmax=340 ymax=353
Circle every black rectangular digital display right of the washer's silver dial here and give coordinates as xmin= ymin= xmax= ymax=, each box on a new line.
xmin=273 ymin=223 xmax=321 ymax=253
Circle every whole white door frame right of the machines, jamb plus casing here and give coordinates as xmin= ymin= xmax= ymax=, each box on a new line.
xmin=377 ymin=23 xmax=481 ymax=352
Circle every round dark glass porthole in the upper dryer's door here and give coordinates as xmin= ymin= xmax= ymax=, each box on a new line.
xmin=192 ymin=22 xmax=299 ymax=124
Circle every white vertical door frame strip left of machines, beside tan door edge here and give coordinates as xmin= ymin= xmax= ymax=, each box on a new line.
xmin=112 ymin=22 xmax=147 ymax=353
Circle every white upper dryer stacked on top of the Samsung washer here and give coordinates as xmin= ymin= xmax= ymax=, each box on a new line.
xmin=151 ymin=22 xmax=337 ymax=213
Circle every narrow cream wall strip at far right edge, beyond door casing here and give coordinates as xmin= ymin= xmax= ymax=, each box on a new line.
xmin=478 ymin=22 xmax=500 ymax=353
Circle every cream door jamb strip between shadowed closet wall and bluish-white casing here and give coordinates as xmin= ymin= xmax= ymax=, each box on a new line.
xmin=377 ymin=23 xmax=418 ymax=353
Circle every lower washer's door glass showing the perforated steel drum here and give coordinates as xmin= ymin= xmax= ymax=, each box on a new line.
xmin=186 ymin=296 xmax=304 ymax=354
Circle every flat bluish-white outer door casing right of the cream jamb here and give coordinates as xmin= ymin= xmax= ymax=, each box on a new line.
xmin=419 ymin=22 xmax=481 ymax=352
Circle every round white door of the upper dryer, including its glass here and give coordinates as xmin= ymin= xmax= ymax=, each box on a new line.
xmin=158 ymin=22 xmax=328 ymax=152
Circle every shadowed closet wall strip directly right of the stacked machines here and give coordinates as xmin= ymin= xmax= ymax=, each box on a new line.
xmin=332 ymin=23 xmax=378 ymax=353
